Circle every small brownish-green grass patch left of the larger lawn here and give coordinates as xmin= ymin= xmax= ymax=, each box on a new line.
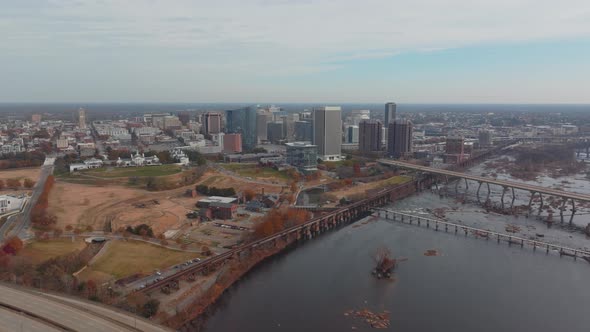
xmin=18 ymin=239 xmax=86 ymax=264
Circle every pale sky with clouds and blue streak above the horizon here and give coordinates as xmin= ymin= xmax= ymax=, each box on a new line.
xmin=0 ymin=0 xmax=590 ymax=103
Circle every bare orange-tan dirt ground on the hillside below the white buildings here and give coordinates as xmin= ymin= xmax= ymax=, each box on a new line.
xmin=49 ymin=171 xmax=281 ymax=235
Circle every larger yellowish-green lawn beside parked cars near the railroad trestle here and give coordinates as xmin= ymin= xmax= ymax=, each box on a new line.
xmin=87 ymin=241 xmax=198 ymax=279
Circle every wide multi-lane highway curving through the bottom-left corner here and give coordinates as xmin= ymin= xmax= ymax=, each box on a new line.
xmin=0 ymin=284 xmax=171 ymax=332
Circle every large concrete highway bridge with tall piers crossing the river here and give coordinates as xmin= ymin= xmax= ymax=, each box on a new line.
xmin=379 ymin=159 xmax=590 ymax=225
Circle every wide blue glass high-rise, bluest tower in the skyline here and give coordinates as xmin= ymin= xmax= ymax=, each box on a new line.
xmin=225 ymin=107 xmax=258 ymax=150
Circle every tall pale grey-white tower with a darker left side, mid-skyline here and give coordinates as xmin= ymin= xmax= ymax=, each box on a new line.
xmin=313 ymin=106 xmax=342 ymax=160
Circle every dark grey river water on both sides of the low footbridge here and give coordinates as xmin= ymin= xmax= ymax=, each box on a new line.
xmin=197 ymin=189 xmax=590 ymax=332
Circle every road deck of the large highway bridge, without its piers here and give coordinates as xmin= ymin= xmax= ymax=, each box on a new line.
xmin=379 ymin=159 xmax=590 ymax=202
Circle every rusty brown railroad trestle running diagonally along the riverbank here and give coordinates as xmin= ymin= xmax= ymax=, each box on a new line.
xmin=137 ymin=181 xmax=416 ymax=293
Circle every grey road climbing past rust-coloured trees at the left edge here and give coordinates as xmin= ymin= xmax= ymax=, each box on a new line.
xmin=0 ymin=158 xmax=55 ymax=242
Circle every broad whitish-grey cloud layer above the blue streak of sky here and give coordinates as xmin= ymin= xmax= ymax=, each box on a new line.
xmin=0 ymin=0 xmax=590 ymax=101
